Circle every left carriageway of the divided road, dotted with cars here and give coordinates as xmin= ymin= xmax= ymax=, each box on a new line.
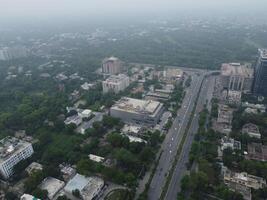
xmin=148 ymin=71 xmax=205 ymax=200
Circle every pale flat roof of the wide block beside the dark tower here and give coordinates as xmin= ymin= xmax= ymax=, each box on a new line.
xmin=221 ymin=63 xmax=254 ymax=78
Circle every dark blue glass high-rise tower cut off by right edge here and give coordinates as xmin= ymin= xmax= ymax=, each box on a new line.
xmin=253 ymin=49 xmax=267 ymax=97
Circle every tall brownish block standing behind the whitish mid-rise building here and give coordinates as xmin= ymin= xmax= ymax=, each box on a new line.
xmin=102 ymin=57 xmax=122 ymax=75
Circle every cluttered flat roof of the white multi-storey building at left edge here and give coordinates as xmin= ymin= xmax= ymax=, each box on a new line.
xmin=0 ymin=136 xmax=31 ymax=163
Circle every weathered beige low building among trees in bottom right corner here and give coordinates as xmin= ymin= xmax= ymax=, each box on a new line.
xmin=222 ymin=167 xmax=266 ymax=200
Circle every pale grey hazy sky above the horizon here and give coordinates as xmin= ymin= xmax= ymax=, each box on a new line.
xmin=0 ymin=0 xmax=267 ymax=23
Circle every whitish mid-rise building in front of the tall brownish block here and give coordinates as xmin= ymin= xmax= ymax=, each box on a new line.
xmin=102 ymin=74 xmax=130 ymax=94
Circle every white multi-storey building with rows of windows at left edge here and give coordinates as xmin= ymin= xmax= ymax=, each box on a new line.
xmin=0 ymin=137 xmax=33 ymax=179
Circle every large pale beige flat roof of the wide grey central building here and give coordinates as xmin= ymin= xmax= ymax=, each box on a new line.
xmin=112 ymin=97 xmax=162 ymax=114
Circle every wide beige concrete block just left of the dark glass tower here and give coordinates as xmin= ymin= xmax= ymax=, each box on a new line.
xmin=221 ymin=63 xmax=254 ymax=93
